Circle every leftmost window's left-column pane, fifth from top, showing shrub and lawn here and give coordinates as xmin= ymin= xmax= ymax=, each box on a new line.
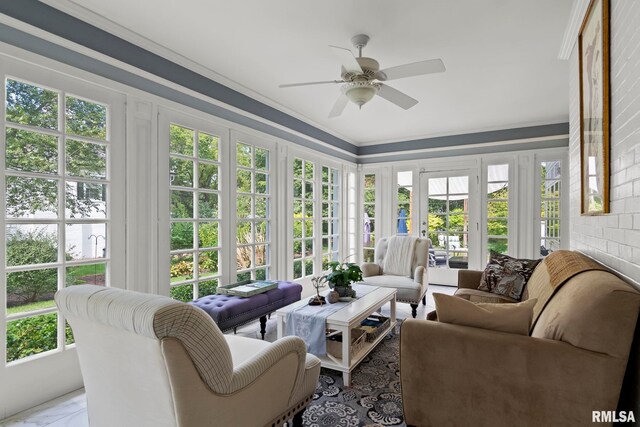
xmin=7 ymin=268 xmax=58 ymax=314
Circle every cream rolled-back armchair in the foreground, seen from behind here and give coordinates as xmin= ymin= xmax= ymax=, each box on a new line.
xmin=55 ymin=285 xmax=320 ymax=427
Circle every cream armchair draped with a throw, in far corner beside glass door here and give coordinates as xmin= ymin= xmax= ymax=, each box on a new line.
xmin=362 ymin=237 xmax=431 ymax=318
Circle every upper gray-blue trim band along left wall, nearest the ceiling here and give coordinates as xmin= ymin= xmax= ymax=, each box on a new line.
xmin=0 ymin=0 xmax=358 ymax=155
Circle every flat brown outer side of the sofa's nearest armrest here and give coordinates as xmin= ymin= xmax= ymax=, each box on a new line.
xmin=400 ymin=319 xmax=625 ymax=426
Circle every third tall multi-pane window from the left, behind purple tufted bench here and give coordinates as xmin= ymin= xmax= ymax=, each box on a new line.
xmin=236 ymin=140 xmax=272 ymax=281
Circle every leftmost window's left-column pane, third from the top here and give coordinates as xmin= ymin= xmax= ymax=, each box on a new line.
xmin=5 ymin=176 xmax=59 ymax=218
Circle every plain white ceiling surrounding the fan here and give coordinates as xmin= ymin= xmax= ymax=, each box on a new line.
xmin=57 ymin=0 xmax=572 ymax=145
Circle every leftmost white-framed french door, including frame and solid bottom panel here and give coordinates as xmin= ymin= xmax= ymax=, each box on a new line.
xmin=0 ymin=57 xmax=125 ymax=419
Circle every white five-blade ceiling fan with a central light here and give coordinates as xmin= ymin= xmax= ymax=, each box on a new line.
xmin=279 ymin=34 xmax=446 ymax=118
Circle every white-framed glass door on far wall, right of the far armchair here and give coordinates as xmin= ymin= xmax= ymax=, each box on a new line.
xmin=420 ymin=170 xmax=480 ymax=285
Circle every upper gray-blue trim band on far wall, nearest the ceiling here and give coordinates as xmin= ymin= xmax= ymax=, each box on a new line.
xmin=358 ymin=122 xmax=569 ymax=156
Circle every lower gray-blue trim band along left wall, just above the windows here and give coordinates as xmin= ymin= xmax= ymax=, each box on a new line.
xmin=0 ymin=23 xmax=357 ymax=163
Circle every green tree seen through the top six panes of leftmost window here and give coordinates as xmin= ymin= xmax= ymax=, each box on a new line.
xmin=5 ymin=79 xmax=106 ymax=217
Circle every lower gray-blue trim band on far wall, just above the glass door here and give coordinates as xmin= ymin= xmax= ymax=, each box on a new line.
xmin=358 ymin=137 xmax=569 ymax=164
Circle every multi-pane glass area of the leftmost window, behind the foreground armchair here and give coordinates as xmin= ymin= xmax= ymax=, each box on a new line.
xmin=0 ymin=78 xmax=123 ymax=362
